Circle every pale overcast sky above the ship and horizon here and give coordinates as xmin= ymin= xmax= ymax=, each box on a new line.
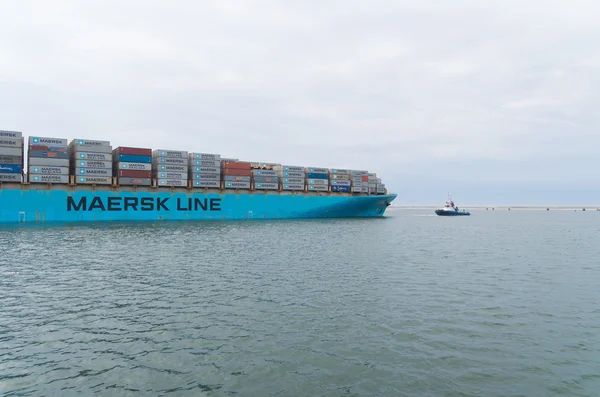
xmin=0 ymin=0 xmax=600 ymax=205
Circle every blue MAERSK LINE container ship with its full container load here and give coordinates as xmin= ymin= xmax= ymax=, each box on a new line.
xmin=0 ymin=130 xmax=396 ymax=224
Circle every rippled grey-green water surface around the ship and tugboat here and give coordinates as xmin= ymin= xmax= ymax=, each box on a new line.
xmin=0 ymin=210 xmax=600 ymax=396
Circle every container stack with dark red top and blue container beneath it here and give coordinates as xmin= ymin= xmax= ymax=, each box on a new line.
xmin=113 ymin=146 xmax=152 ymax=186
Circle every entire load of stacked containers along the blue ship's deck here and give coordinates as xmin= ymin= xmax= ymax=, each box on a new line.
xmin=0 ymin=131 xmax=387 ymax=194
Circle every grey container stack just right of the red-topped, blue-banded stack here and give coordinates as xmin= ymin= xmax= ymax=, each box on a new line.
xmin=152 ymin=149 xmax=189 ymax=187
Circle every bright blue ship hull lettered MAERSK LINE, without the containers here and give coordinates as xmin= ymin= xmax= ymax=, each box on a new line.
xmin=0 ymin=184 xmax=396 ymax=224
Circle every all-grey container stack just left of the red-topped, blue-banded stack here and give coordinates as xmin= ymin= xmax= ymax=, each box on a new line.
xmin=69 ymin=139 xmax=113 ymax=185
